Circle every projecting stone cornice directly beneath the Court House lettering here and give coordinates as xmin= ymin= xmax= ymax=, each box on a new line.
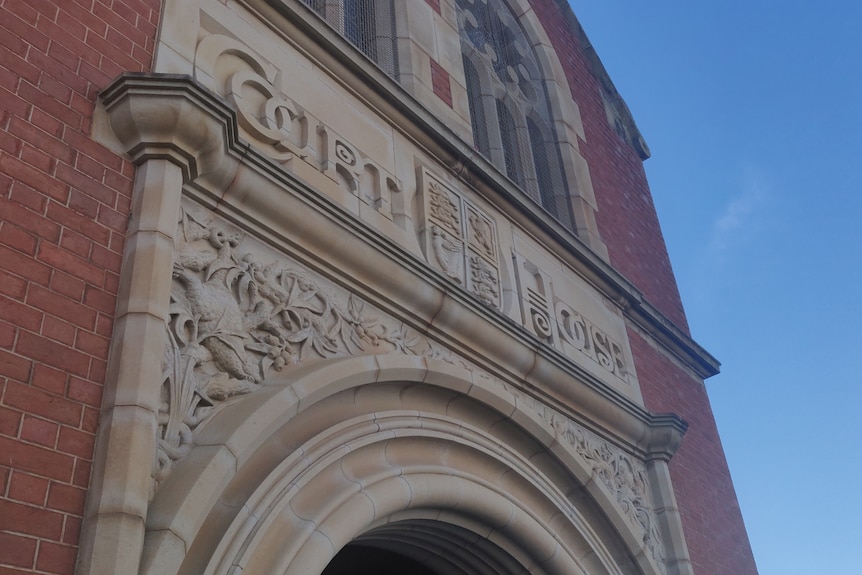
xmin=101 ymin=74 xmax=686 ymax=459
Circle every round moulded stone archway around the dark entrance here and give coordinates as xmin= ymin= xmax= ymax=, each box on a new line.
xmin=141 ymin=356 xmax=676 ymax=575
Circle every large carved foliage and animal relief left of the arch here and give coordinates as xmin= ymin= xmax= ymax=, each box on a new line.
xmin=154 ymin=203 xmax=467 ymax=481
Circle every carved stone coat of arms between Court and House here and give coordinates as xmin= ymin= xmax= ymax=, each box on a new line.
xmin=419 ymin=168 xmax=501 ymax=309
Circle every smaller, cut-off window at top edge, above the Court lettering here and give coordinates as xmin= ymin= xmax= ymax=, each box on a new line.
xmin=302 ymin=0 xmax=398 ymax=78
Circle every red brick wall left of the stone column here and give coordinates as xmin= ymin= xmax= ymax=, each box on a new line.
xmin=0 ymin=0 xmax=161 ymax=575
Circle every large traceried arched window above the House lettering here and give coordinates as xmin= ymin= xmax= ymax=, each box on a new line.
xmin=456 ymin=0 xmax=572 ymax=227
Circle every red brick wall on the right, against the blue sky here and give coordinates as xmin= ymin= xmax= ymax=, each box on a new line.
xmin=531 ymin=0 xmax=757 ymax=575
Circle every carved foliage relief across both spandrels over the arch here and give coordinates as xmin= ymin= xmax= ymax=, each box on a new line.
xmin=153 ymin=202 xmax=681 ymax=572
